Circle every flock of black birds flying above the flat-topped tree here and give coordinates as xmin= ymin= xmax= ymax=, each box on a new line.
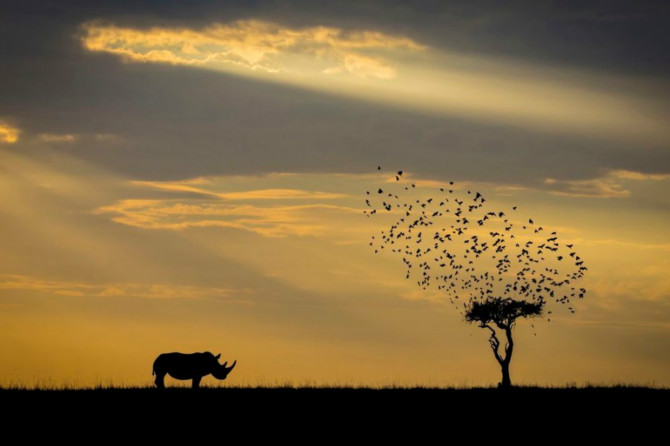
xmin=364 ymin=166 xmax=587 ymax=315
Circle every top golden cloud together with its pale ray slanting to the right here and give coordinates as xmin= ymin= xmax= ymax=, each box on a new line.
xmin=82 ymin=20 xmax=670 ymax=144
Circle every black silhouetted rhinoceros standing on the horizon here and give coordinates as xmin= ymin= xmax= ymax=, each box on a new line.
xmin=152 ymin=352 xmax=237 ymax=389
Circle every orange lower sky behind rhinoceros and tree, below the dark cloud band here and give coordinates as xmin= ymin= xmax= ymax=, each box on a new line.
xmin=0 ymin=151 xmax=670 ymax=385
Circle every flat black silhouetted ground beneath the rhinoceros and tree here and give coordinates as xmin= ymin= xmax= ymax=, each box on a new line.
xmin=0 ymin=387 xmax=670 ymax=436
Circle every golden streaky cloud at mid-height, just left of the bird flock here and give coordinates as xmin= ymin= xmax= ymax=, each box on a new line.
xmin=94 ymin=179 xmax=360 ymax=237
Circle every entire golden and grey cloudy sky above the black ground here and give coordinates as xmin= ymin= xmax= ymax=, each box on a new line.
xmin=0 ymin=0 xmax=670 ymax=386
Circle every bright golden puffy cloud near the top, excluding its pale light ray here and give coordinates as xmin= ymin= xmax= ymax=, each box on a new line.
xmin=82 ymin=20 xmax=422 ymax=79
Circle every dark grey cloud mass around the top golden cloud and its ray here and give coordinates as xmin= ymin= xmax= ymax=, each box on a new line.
xmin=0 ymin=1 xmax=670 ymax=183
